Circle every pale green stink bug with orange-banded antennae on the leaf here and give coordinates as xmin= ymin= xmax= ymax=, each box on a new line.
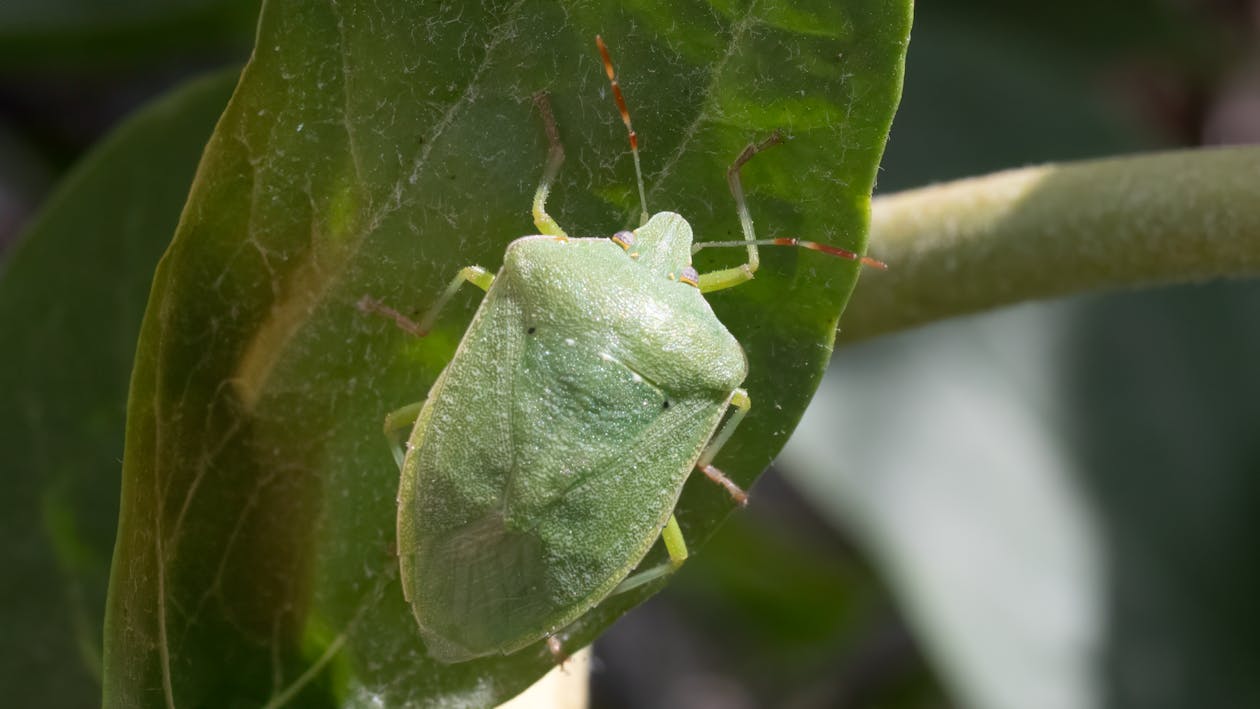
xmin=360 ymin=38 xmax=878 ymax=662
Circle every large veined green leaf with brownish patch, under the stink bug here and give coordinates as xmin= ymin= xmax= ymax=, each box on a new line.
xmin=105 ymin=0 xmax=910 ymax=706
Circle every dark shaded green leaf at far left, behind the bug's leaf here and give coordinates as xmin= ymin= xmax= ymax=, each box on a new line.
xmin=0 ymin=71 xmax=238 ymax=706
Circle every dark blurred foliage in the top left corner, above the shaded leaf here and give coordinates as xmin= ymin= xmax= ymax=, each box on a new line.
xmin=0 ymin=0 xmax=258 ymax=258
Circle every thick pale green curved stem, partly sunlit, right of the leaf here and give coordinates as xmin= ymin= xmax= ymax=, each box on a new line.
xmin=839 ymin=147 xmax=1260 ymax=343
